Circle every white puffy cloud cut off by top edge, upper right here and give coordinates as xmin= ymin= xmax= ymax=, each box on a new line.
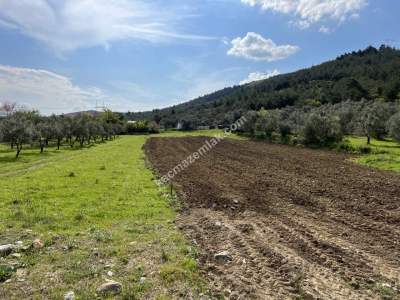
xmin=241 ymin=0 xmax=368 ymax=29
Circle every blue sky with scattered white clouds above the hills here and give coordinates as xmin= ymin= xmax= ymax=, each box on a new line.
xmin=0 ymin=0 xmax=400 ymax=114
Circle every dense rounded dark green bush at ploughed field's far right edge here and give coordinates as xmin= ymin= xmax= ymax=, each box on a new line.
xmin=302 ymin=114 xmax=343 ymax=146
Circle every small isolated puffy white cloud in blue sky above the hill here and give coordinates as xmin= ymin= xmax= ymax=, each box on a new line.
xmin=228 ymin=32 xmax=300 ymax=62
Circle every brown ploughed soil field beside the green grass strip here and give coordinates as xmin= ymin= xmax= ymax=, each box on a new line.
xmin=145 ymin=137 xmax=400 ymax=299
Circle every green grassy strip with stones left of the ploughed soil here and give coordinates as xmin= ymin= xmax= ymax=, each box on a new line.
xmin=0 ymin=136 xmax=209 ymax=299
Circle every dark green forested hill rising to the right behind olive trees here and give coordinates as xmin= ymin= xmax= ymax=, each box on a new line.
xmin=128 ymin=46 xmax=400 ymax=127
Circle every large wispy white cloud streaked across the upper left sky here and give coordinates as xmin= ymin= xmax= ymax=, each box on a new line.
xmin=0 ymin=0 xmax=210 ymax=54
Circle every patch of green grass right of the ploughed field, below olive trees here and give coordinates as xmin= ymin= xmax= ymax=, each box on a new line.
xmin=347 ymin=136 xmax=400 ymax=172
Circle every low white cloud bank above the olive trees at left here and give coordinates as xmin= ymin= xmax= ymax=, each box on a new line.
xmin=0 ymin=65 xmax=133 ymax=114
